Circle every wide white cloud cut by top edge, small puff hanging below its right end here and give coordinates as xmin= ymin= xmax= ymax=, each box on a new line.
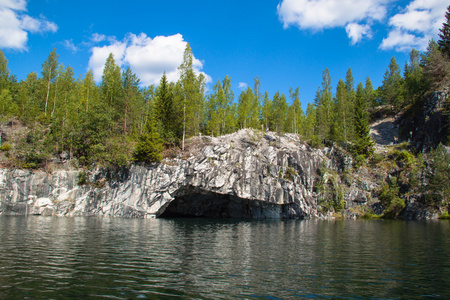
xmin=277 ymin=0 xmax=389 ymax=44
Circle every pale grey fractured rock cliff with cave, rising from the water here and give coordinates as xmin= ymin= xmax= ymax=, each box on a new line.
xmin=0 ymin=129 xmax=436 ymax=219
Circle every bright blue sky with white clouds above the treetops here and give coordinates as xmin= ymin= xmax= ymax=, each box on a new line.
xmin=0 ymin=0 xmax=449 ymax=109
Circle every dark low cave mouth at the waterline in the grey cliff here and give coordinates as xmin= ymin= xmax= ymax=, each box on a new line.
xmin=159 ymin=193 xmax=283 ymax=219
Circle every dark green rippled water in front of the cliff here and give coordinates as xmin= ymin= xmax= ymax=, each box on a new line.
xmin=0 ymin=216 xmax=450 ymax=299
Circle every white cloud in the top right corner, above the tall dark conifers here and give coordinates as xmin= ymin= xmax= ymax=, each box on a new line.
xmin=380 ymin=0 xmax=448 ymax=51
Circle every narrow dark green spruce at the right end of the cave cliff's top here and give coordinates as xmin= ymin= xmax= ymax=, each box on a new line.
xmin=355 ymin=83 xmax=373 ymax=155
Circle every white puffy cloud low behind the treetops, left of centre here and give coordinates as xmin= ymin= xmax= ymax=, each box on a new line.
xmin=89 ymin=33 xmax=211 ymax=85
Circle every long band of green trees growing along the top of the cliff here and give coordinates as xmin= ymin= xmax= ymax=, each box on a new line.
xmin=0 ymin=7 xmax=450 ymax=165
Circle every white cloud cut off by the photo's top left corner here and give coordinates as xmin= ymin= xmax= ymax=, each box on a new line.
xmin=0 ymin=0 xmax=58 ymax=50
